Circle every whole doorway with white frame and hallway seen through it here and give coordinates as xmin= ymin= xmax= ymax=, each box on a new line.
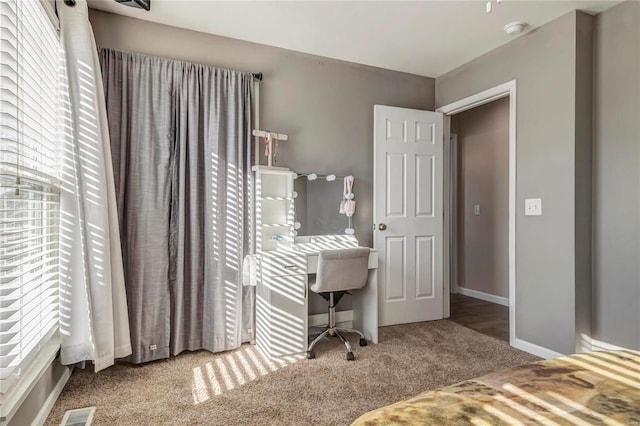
xmin=438 ymin=81 xmax=516 ymax=345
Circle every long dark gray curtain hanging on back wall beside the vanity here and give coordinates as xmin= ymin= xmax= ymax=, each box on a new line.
xmin=100 ymin=49 xmax=254 ymax=363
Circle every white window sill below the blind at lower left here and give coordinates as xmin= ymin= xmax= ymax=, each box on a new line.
xmin=0 ymin=335 xmax=60 ymax=425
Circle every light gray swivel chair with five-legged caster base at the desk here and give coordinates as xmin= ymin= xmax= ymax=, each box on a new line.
xmin=307 ymin=247 xmax=370 ymax=361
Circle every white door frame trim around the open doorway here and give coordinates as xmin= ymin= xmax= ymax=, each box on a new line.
xmin=436 ymin=80 xmax=517 ymax=346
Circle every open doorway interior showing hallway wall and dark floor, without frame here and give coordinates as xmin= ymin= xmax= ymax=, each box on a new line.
xmin=450 ymin=97 xmax=509 ymax=341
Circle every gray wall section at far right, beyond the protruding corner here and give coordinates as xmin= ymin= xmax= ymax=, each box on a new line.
xmin=593 ymin=1 xmax=640 ymax=349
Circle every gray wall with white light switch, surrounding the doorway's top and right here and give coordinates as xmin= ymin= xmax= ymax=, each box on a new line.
xmin=436 ymin=12 xmax=591 ymax=353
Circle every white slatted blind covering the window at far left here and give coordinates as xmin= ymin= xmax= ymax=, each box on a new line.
xmin=0 ymin=0 xmax=61 ymax=393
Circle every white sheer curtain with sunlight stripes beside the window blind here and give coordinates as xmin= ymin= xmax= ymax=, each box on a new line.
xmin=56 ymin=0 xmax=131 ymax=371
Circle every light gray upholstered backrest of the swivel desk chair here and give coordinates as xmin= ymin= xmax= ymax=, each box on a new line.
xmin=311 ymin=247 xmax=371 ymax=293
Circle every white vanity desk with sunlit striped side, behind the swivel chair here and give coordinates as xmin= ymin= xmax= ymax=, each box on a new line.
xmin=256 ymin=241 xmax=378 ymax=359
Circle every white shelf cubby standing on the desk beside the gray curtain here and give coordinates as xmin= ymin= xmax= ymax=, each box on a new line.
xmin=254 ymin=166 xmax=295 ymax=253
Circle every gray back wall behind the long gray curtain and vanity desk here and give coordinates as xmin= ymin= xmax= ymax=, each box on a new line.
xmin=89 ymin=10 xmax=434 ymax=246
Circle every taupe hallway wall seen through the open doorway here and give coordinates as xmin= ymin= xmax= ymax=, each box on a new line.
xmin=451 ymin=98 xmax=509 ymax=298
